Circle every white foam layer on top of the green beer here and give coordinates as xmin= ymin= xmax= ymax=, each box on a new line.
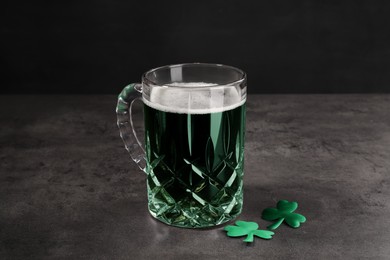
xmin=143 ymin=82 xmax=245 ymax=114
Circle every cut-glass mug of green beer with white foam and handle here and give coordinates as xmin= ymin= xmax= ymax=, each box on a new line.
xmin=116 ymin=63 xmax=246 ymax=228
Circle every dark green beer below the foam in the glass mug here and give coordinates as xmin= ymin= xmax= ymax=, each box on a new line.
xmin=144 ymin=104 xmax=245 ymax=228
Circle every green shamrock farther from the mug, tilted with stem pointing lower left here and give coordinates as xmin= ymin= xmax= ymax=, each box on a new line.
xmin=262 ymin=200 xmax=306 ymax=230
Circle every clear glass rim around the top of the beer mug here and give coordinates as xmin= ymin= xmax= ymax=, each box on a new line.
xmin=142 ymin=62 xmax=246 ymax=89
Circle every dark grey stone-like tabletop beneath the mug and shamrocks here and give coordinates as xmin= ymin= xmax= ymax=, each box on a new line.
xmin=0 ymin=94 xmax=390 ymax=259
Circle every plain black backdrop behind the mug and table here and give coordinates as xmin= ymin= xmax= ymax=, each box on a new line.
xmin=0 ymin=0 xmax=390 ymax=94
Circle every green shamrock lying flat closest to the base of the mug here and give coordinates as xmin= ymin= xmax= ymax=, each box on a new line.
xmin=224 ymin=221 xmax=275 ymax=242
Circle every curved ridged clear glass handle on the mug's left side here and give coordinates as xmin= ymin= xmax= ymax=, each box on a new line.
xmin=116 ymin=83 xmax=146 ymax=172
